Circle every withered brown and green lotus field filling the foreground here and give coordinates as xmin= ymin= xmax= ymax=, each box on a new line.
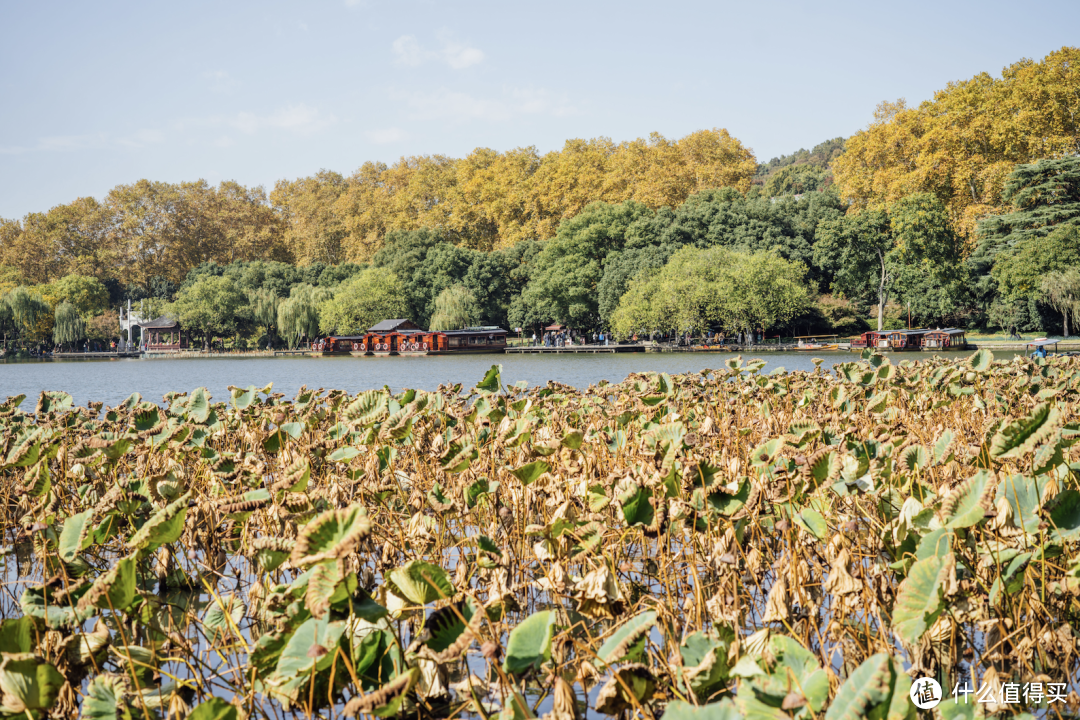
xmin=0 ymin=351 xmax=1080 ymax=720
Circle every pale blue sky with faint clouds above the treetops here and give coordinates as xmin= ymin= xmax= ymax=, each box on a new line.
xmin=0 ymin=0 xmax=1080 ymax=218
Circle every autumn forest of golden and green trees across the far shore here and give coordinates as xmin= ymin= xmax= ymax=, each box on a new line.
xmin=0 ymin=47 xmax=1080 ymax=350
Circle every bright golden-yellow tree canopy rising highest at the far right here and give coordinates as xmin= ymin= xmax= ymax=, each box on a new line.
xmin=833 ymin=47 xmax=1080 ymax=241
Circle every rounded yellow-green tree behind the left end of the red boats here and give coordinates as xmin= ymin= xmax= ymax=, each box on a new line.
xmin=319 ymin=268 xmax=408 ymax=335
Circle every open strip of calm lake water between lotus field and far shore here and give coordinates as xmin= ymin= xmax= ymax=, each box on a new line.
xmin=0 ymin=352 xmax=980 ymax=407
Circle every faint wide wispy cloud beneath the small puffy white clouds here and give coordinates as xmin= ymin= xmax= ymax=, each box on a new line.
xmin=394 ymin=87 xmax=577 ymax=122
